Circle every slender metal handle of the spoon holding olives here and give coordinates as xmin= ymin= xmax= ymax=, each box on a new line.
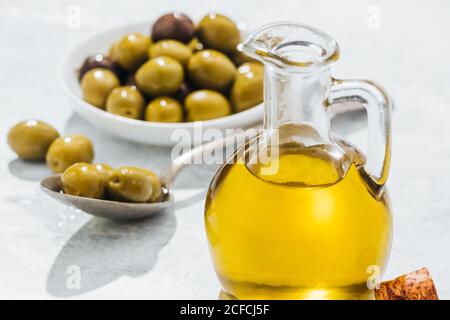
xmin=160 ymin=124 xmax=261 ymax=189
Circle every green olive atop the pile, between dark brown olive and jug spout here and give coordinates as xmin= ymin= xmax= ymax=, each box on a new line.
xmin=198 ymin=13 xmax=241 ymax=53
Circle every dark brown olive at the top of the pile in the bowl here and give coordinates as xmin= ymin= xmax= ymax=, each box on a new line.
xmin=151 ymin=12 xmax=195 ymax=43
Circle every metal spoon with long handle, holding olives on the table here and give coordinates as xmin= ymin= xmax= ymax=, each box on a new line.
xmin=40 ymin=131 xmax=248 ymax=220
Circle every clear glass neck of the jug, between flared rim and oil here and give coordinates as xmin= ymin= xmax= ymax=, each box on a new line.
xmin=264 ymin=64 xmax=331 ymax=142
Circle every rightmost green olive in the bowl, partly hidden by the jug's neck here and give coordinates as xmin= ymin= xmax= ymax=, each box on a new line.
xmin=231 ymin=62 xmax=264 ymax=112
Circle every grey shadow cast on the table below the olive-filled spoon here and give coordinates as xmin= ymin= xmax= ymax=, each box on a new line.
xmin=47 ymin=210 xmax=176 ymax=297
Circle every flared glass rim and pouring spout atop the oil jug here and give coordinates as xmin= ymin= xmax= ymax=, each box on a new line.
xmin=242 ymin=22 xmax=339 ymax=72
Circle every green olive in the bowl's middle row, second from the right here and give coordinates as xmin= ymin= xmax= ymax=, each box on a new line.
xmin=188 ymin=50 xmax=236 ymax=91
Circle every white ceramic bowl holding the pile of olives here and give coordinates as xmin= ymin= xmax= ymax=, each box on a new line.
xmin=59 ymin=22 xmax=263 ymax=146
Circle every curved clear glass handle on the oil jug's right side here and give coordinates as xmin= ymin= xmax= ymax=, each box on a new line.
xmin=328 ymin=79 xmax=392 ymax=195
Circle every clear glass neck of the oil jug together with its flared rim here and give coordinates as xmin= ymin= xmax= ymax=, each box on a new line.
xmin=243 ymin=22 xmax=339 ymax=145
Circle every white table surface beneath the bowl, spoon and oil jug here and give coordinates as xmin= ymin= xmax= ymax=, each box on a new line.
xmin=0 ymin=0 xmax=450 ymax=299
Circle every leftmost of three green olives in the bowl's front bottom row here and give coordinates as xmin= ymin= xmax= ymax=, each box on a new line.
xmin=106 ymin=86 xmax=145 ymax=119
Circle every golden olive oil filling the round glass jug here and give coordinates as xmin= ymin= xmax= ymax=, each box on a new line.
xmin=205 ymin=142 xmax=392 ymax=299
